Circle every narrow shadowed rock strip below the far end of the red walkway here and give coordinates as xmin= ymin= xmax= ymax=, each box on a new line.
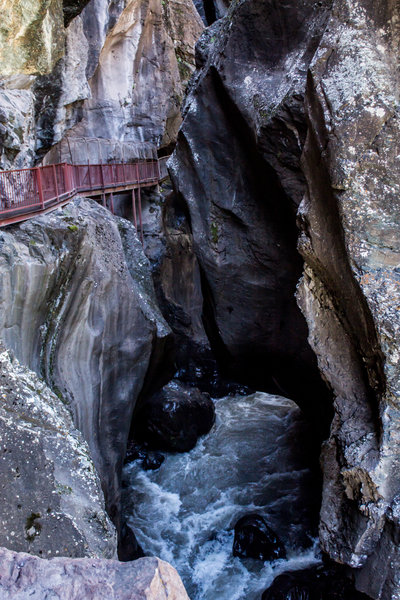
xmin=142 ymin=182 xmax=211 ymax=381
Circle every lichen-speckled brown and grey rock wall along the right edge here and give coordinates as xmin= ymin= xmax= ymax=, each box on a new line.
xmin=299 ymin=0 xmax=400 ymax=600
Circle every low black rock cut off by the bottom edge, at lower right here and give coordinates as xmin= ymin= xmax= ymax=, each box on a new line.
xmin=262 ymin=566 xmax=368 ymax=600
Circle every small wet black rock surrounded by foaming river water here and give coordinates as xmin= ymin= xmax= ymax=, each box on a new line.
xmin=233 ymin=514 xmax=286 ymax=561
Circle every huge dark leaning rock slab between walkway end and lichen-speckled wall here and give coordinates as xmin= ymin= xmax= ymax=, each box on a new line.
xmin=170 ymin=0 xmax=331 ymax=426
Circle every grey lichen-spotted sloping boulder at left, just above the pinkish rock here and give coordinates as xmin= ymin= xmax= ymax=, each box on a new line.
xmin=0 ymin=344 xmax=117 ymax=560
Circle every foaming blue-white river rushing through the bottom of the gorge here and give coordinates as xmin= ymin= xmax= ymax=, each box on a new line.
xmin=124 ymin=393 xmax=319 ymax=600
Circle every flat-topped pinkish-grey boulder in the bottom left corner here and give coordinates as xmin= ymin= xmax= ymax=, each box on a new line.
xmin=0 ymin=548 xmax=189 ymax=600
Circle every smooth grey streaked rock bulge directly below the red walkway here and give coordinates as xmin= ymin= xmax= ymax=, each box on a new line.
xmin=0 ymin=199 xmax=172 ymax=518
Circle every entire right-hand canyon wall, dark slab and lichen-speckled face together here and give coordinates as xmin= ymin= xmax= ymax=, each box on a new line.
xmin=170 ymin=0 xmax=400 ymax=600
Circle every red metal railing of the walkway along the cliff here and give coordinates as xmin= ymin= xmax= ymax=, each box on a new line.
xmin=0 ymin=160 xmax=164 ymax=227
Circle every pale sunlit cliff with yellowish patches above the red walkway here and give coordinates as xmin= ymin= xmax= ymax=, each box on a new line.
xmin=0 ymin=0 xmax=203 ymax=168
